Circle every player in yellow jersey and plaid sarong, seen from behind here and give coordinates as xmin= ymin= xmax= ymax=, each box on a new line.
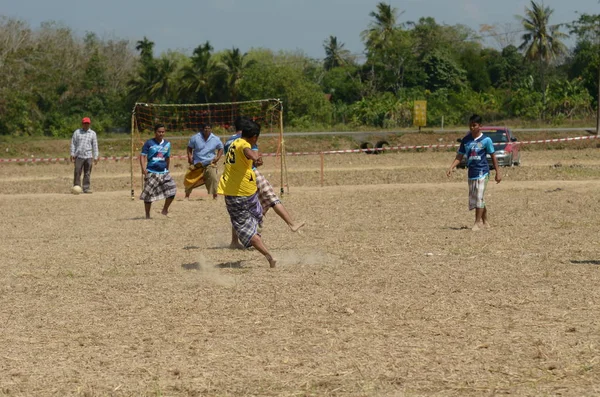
xmin=217 ymin=120 xmax=277 ymax=267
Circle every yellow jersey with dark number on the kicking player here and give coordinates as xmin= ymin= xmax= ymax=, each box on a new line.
xmin=217 ymin=138 xmax=256 ymax=196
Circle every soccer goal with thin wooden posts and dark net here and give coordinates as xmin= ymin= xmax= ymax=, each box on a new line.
xmin=130 ymin=99 xmax=289 ymax=199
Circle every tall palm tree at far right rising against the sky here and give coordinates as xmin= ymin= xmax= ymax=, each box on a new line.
xmin=517 ymin=0 xmax=568 ymax=114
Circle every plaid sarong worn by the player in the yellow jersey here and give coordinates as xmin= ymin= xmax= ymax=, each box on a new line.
xmin=225 ymin=193 xmax=262 ymax=247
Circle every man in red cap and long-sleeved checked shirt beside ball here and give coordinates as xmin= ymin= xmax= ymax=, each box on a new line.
xmin=71 ymin=117 xmax=98 ymax=193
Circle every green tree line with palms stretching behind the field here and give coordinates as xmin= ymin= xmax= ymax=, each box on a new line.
xmin=0 ymin=1 xmax=600 ymax=136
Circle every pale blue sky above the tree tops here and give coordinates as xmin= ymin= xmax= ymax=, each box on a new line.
xmin=0 ymin=0 xmax=600 ymax=58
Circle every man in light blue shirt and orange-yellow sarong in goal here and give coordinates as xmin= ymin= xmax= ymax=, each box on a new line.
xmin=183 ymin=124 xmax=223 ymax=199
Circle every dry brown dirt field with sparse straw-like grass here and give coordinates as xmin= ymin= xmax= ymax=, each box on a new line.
xmin=0 ymin=148 xmax=600 ymax=397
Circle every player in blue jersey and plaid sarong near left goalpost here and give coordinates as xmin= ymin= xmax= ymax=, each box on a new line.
xmin=140 ymin=124 xmax=177 ymax=219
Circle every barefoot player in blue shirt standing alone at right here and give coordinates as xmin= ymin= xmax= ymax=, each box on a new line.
xmin=446 ymin=114 xmax=502 ymax=230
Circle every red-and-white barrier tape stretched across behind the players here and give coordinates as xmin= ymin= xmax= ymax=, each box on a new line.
xmin=0 ymin=135 xmax=600 ymax=163
